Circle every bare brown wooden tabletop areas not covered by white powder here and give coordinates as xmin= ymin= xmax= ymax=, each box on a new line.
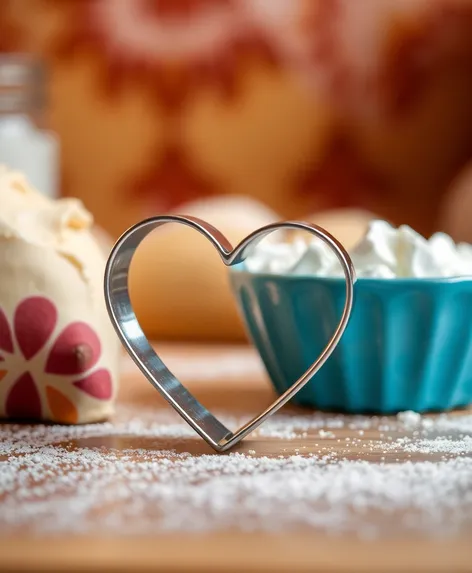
xmin=0 ymin=345 xmax=472 ymax=573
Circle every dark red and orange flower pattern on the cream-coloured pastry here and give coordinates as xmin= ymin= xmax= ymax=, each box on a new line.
xmin=0 ymin=296 xmax=112 ymax=423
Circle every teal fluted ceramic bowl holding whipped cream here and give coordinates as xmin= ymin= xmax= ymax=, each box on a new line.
xmin=230 ymin=263 xmax=472 ymax=414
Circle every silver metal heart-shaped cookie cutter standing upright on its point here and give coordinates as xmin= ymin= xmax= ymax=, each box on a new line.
xmin=104 ymin=215 xmax=356 ymax=452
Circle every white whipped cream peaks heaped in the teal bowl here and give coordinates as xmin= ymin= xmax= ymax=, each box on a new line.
xmin=245 ymin=220 xmax=472 ymax=279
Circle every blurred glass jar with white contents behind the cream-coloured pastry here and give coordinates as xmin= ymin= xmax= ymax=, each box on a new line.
xmin=0 ymin=54 xmax=59 ymax=198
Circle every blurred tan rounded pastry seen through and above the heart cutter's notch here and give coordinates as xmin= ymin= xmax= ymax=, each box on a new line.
xmin=130 ymin=196 xmax=280 ymax=341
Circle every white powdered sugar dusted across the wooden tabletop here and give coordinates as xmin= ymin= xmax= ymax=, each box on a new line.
xmin=0 ymin=406 xmax=472 ymax=538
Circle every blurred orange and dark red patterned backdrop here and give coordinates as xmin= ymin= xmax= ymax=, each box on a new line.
xmin=0 ymin=0 xmax=472 ymax=235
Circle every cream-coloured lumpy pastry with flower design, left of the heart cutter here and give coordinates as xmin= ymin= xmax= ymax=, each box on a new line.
xmin=0 ymin=163 xmax=120 ymax=423
